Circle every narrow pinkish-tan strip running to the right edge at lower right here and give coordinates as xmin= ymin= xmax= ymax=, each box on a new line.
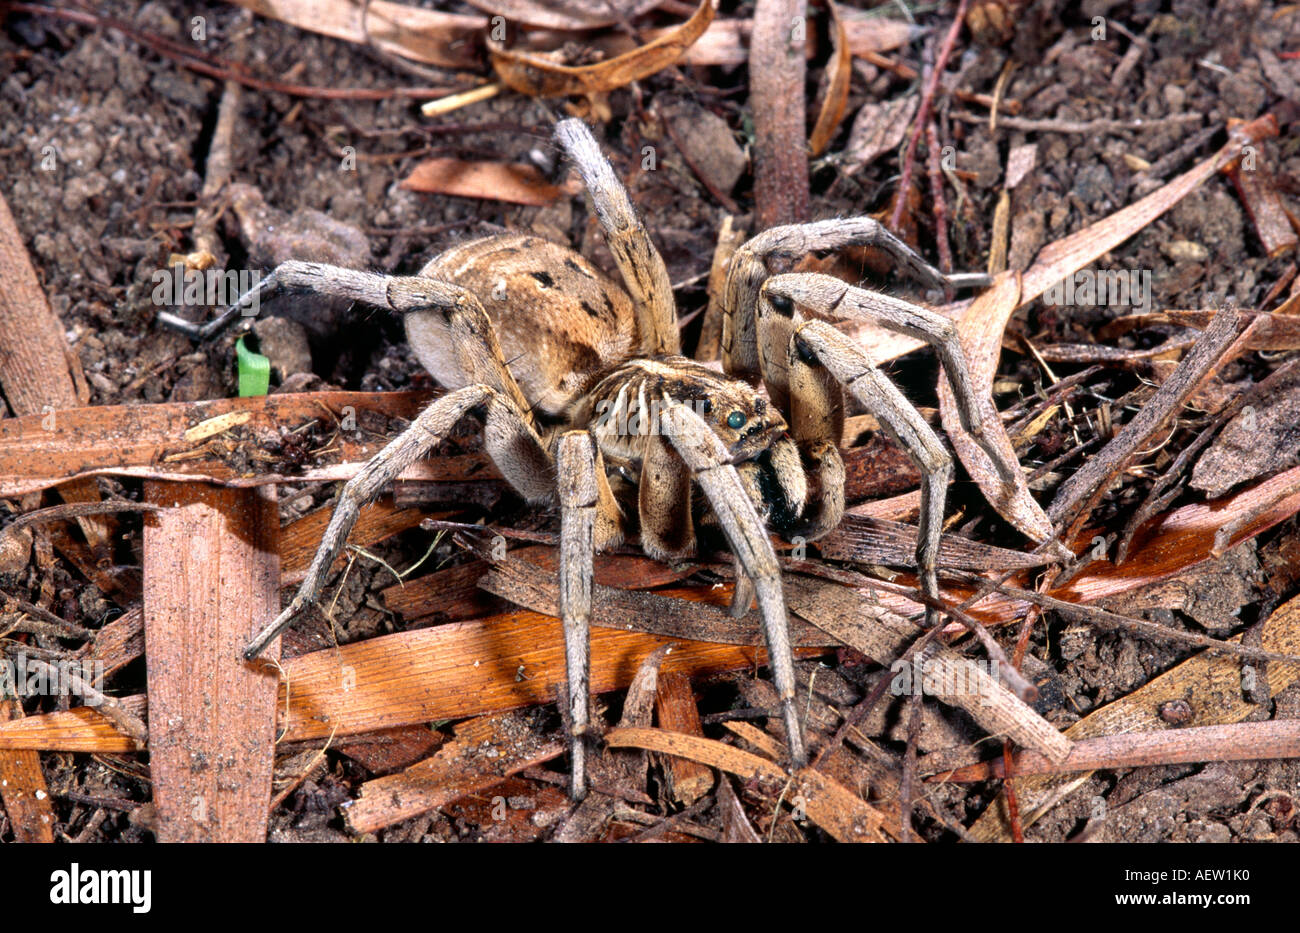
xmin=927 ymin=720 xmax=1300 ymax=781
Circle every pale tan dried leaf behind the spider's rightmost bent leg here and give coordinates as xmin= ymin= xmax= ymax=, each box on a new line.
xmin=939 ymin=272 xmax=1053 ymax=542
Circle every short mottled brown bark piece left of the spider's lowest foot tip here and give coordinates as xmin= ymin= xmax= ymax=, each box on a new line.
xmin=343 ymin=713 xmax=564 ymax=833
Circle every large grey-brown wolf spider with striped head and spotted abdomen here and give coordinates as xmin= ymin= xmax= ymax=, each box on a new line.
xmin=165 ymin=120 xmax=1018 ymax=799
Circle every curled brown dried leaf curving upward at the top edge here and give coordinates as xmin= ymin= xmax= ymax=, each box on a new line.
xmin=488 ymin=0 xmax=714 ymax=97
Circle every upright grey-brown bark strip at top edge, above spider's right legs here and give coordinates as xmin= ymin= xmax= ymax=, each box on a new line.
xmin=749 ymin=0 xmax=810 ymax=230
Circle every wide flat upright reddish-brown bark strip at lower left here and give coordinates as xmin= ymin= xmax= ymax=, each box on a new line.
xmin=144 ymin=482 xmax=280 ymax=842
